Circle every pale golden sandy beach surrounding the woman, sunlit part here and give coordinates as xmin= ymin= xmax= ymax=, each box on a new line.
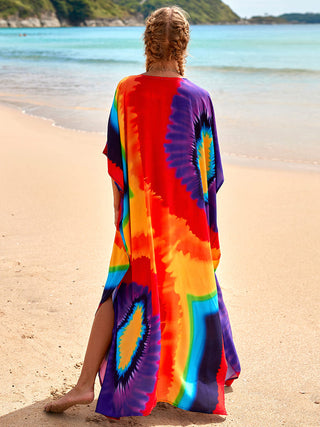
xmin=0 ymin=106 xmax=320 ymax=427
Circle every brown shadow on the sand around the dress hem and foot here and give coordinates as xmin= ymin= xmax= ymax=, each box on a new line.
xmin=0 ymin=399 xmax=225 ymax=427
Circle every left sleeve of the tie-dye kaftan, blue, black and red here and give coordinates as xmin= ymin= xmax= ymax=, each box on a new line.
xmin=103 ymin=88 xmax=124 ymax=192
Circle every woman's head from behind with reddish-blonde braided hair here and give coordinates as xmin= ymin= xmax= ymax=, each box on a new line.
xmin=144 ymin=6 xmax=189 ymax=76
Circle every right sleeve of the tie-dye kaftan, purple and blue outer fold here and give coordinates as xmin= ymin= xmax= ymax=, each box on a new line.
xmin=208 ymin=97 xmax=224 ymax=192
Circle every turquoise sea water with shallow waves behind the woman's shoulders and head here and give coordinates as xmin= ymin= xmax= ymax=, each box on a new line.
xmin=0 ymin=25 xmax=320 ymax=169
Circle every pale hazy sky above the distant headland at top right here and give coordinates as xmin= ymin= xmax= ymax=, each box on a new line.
xmin=224 ymin=0 xmax=320 ymax=18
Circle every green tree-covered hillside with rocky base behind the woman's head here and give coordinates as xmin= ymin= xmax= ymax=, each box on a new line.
xmin=0 ymin=0 xmax=240 ymax=26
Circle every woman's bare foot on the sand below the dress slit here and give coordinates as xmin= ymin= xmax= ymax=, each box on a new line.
xmin=44 ymin=385 xmax=94 ymax=413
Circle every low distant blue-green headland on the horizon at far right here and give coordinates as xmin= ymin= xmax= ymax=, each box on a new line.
xmin=245 ymin=13 xmax=320 ymax=24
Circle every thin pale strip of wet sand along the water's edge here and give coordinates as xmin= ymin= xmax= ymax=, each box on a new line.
xmin=0 ymin=100 xmax=320 ymax=174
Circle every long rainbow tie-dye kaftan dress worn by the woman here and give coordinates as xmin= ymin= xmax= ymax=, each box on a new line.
xmin=96 ymin=74 xmax=240 ymax=418
